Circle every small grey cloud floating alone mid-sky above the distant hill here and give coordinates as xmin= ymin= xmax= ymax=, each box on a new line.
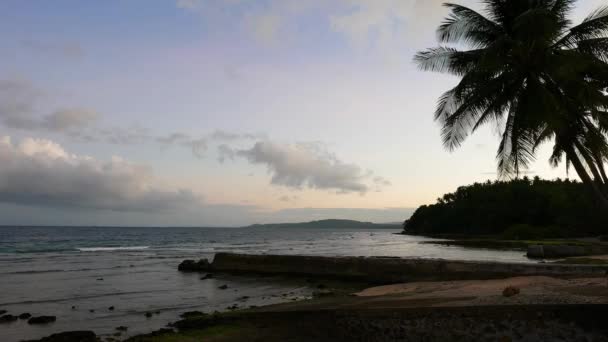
xmin=233 ymin=140 xmax=384 ymax=193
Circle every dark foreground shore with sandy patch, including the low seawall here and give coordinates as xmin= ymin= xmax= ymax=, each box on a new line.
xmin=23 ymin=253 xmax=608 ymax=342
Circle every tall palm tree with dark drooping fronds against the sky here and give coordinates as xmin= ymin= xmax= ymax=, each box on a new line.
xmin=414 ymin=0 xmax=608 ymax=208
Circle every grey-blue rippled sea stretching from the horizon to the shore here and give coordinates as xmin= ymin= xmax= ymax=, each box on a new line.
xmin=0 ymin=227 xmax=532 ymax=342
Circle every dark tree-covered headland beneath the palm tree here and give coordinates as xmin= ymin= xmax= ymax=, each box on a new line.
xmin=404 ymin=178 xmax=608 ymax=239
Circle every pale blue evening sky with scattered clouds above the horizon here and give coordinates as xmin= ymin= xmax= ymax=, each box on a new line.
xmin=0 ymin=0 xmax=604 ymax=226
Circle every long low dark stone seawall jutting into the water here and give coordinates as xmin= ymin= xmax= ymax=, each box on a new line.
xmin=178 ymin=253 xmax=608 ymax=283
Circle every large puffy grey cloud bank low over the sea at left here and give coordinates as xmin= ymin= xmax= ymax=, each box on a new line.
xmin=0 ymin=136 xmax=201 ymax=212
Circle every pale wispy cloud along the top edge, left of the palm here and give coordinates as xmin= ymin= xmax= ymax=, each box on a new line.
xmin=176 ymin=0 xmax=452 ymax=57
